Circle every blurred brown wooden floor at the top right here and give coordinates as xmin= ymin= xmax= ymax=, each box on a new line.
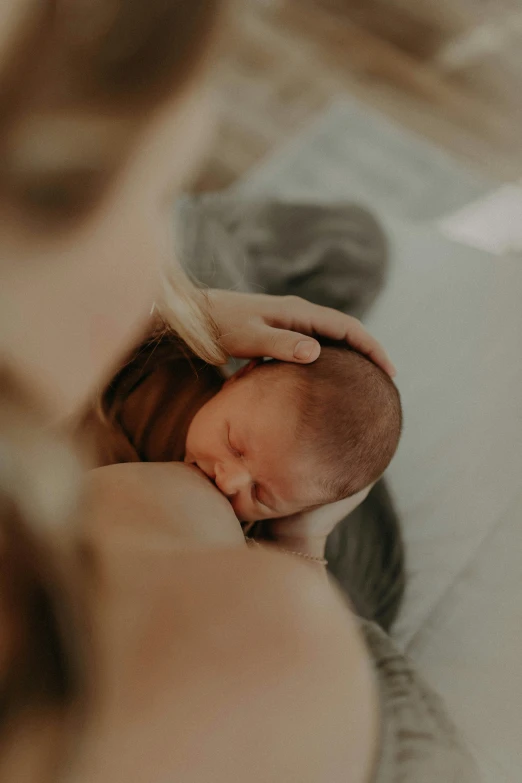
xmin=195 ymin=0 xmax=522 ymax=190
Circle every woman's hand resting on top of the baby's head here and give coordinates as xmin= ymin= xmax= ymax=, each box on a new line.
xmin=207 ymin=289 xmax=395 ymax=377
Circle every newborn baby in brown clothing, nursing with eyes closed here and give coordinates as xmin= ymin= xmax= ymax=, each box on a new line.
xmin=81 ymin=336 xmax=402 ymax=522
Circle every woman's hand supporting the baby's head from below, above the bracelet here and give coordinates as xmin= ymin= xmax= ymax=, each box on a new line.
xmin=265 ymin=484 xmax=373 ymax=557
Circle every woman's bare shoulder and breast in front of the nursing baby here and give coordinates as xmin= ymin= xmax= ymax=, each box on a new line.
xmin=82 ymin=464 xmax=377 ymax=783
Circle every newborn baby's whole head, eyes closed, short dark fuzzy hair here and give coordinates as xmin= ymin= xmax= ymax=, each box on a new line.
xmin=185 ymin=345 xmax=402 ymax=522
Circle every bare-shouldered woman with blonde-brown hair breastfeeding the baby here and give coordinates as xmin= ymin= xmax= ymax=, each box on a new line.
xmin=0 ymin=0 xmax=478 ymax=783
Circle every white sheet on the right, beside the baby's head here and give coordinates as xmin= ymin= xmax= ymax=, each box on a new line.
xmin=362 ymin=220 xmax=522 ymax=783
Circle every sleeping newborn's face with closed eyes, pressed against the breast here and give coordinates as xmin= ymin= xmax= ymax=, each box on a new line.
xmin=185 ymin=373 xmax=320 ymax=522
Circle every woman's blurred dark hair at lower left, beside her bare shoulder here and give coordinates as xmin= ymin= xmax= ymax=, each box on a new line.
xmin=0 ymin=368 xmax=91 ymax=781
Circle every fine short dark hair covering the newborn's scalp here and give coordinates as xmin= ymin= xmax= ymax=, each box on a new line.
xmin=250 ymin=343 xmax=402 ymax=503
